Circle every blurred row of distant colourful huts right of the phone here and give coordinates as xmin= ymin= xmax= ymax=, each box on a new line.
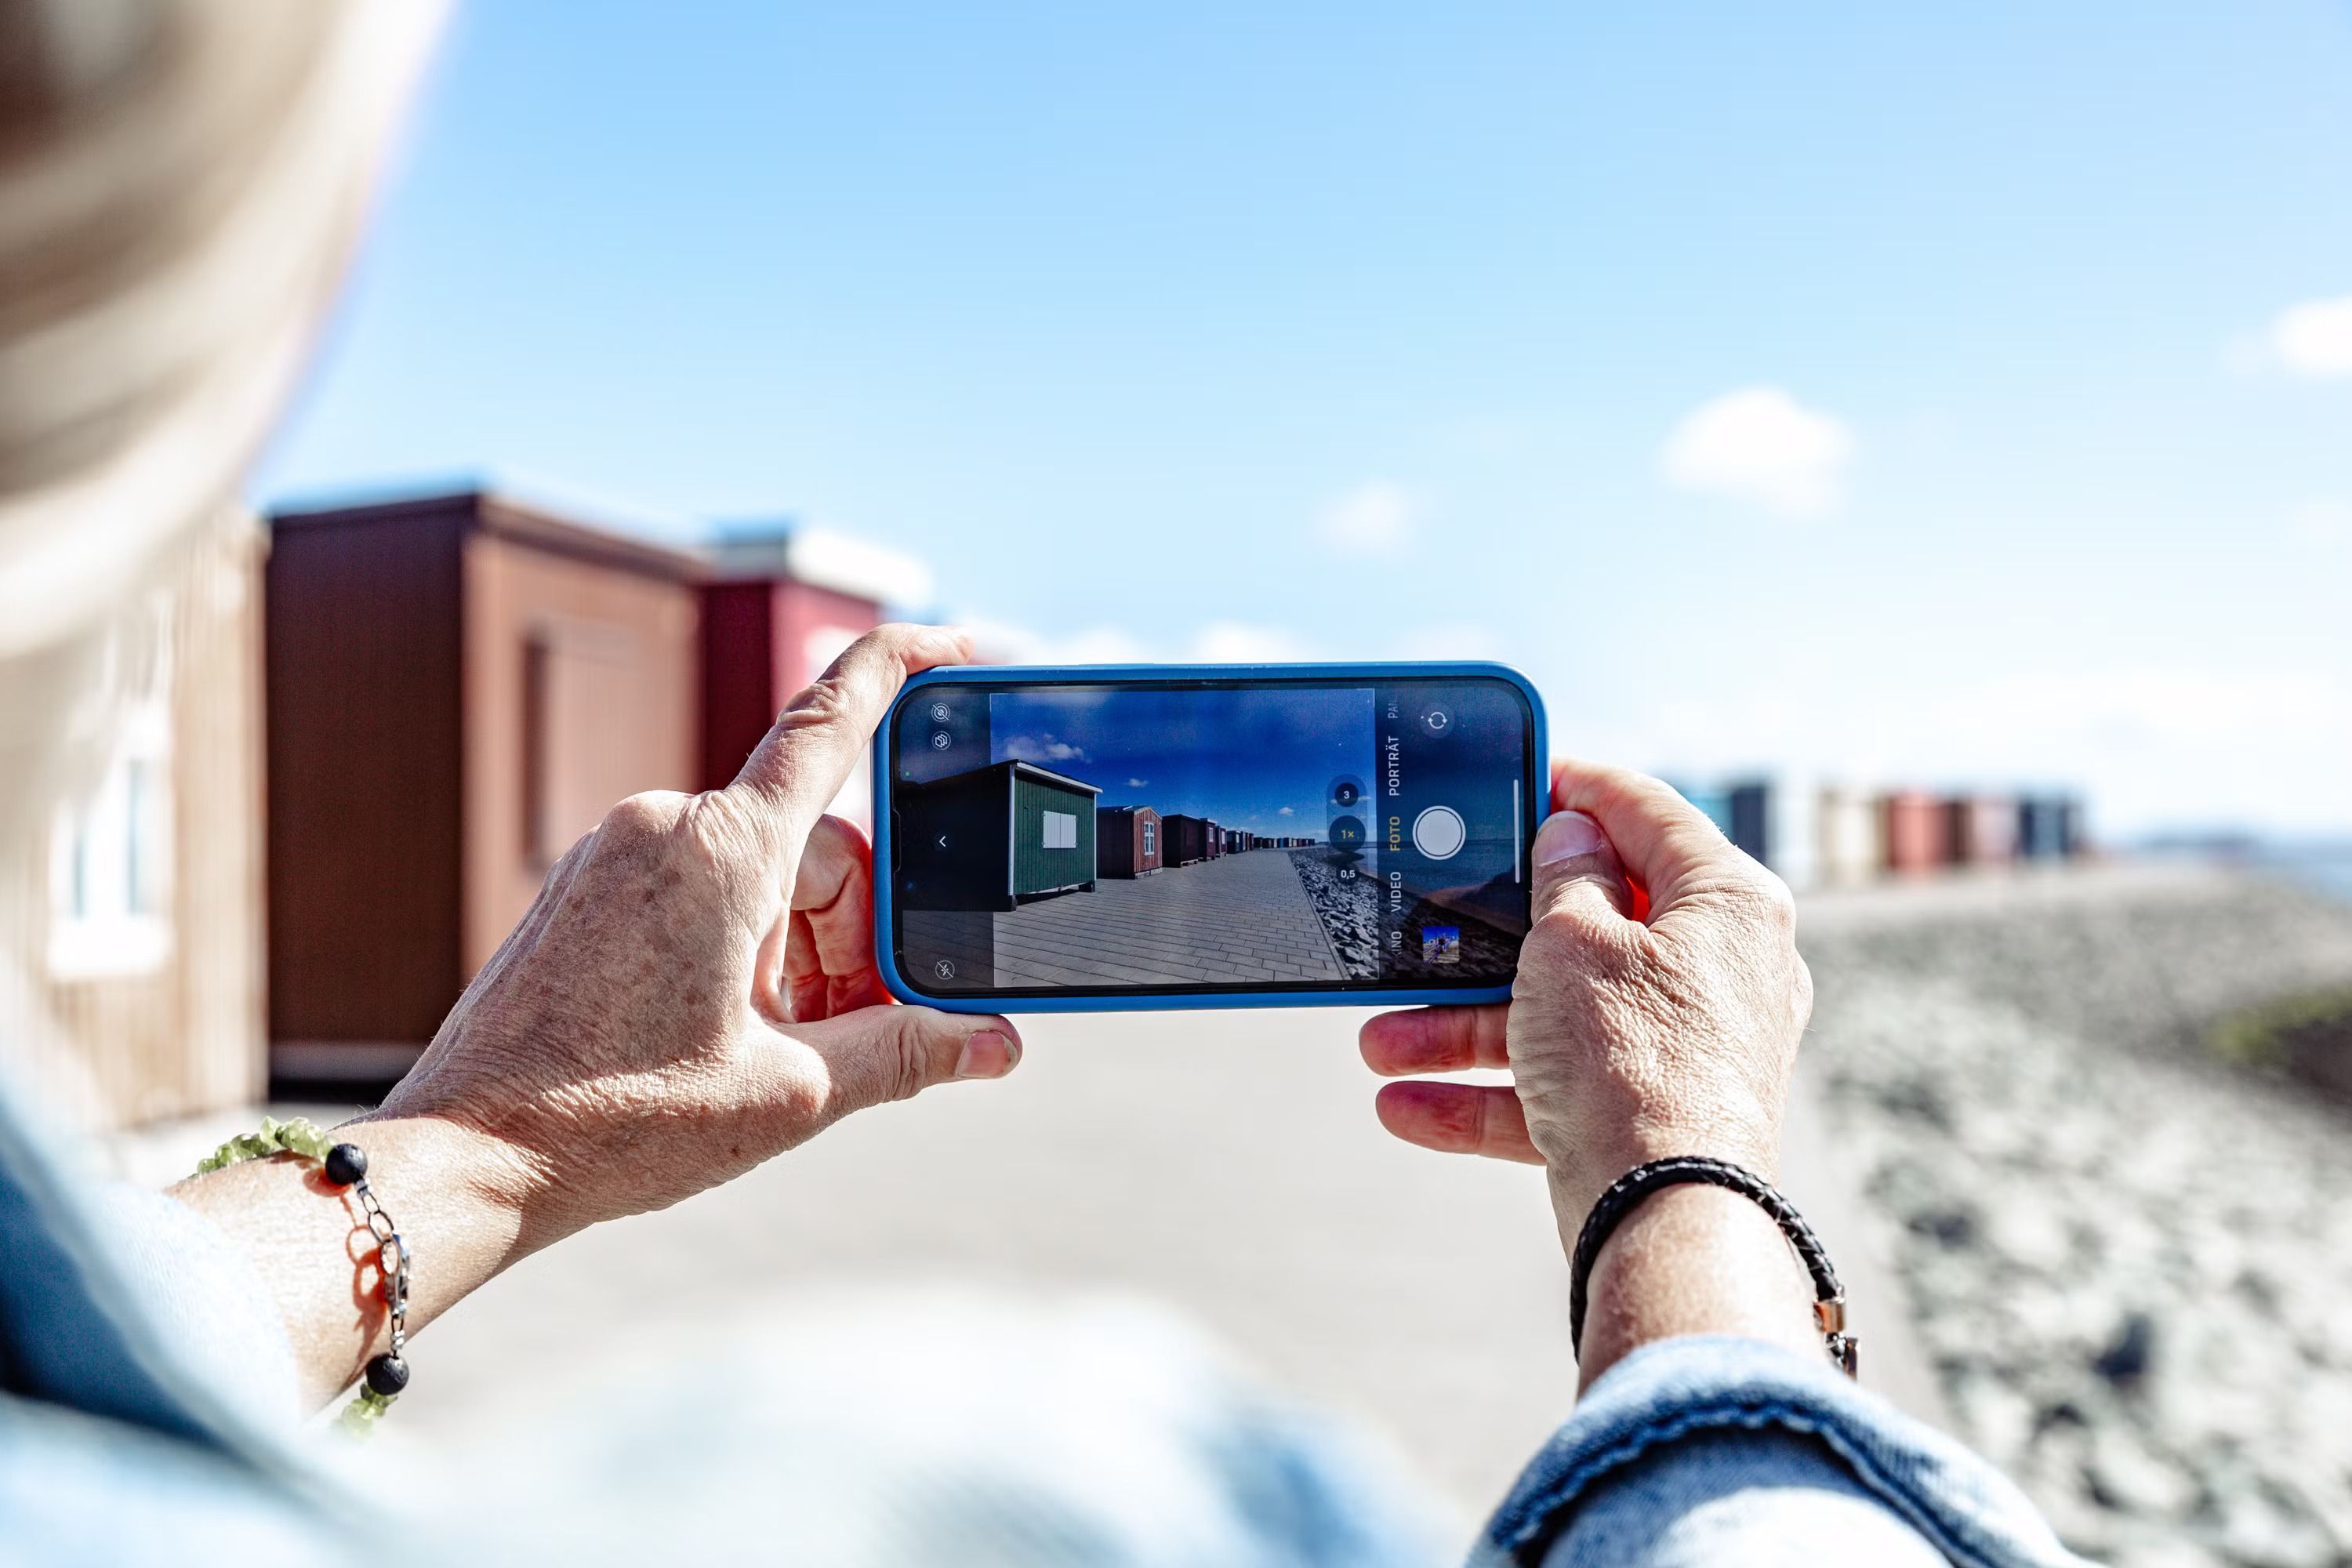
xmin=1675 ymin=779 xmax=2089 ymax=884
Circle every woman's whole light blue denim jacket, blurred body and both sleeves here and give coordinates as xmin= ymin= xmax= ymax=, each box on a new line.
xmin=0 ymin=1081 xmax=2074 ymax=1568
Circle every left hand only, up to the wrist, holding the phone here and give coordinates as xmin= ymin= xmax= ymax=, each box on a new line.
xmin=379 ymin=626 xmax=1021 ymax=1250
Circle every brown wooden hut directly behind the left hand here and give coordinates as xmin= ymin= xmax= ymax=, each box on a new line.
xmin=261 ymin=487 xmax=696 ymax=1102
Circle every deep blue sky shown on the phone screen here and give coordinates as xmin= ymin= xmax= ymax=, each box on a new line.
xmin=988 ymin=687 xmax=1374 ymax=839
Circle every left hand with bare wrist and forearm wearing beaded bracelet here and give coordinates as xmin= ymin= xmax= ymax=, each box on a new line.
xmin=174 ymin=626 xmax=1021 ymax=1401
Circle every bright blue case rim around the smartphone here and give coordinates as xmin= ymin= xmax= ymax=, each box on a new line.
xmin=873 ymin=661 xmax=1552 ymax=1013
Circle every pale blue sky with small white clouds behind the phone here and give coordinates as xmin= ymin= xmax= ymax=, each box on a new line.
xmin=256 ymin=0 xmax=2352 ymax=832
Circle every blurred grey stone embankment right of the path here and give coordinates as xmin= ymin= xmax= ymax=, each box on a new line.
xmin=1804 ymin=872 xmax=2352 ymax=1566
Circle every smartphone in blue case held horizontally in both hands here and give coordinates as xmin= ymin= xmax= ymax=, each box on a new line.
xmin=873 ymin=663 xmax=1550 ymax=1013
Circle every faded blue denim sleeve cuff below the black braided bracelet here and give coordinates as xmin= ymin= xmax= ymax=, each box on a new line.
xmin=1470 ymin=1335 xmax=2082 ymax=1568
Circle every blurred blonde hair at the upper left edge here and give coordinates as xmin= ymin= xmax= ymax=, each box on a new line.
xmin=0 ymin=0 xmax=442 ymax=1123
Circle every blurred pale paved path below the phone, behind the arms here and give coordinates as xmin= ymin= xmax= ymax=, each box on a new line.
xmin=111 ymin=926 xmax=1940 ymax=1530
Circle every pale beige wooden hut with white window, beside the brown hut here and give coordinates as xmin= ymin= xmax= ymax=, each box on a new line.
xmin=26 ymin=508 xmax=269 ymax=1123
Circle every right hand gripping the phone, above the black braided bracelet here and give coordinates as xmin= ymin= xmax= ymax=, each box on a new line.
xmin=1362 ymin=762 xmax=1813 ymax=1248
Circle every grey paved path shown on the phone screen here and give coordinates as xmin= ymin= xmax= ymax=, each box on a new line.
xmin=906 ymin=848 xmax=1348 ymax=985
